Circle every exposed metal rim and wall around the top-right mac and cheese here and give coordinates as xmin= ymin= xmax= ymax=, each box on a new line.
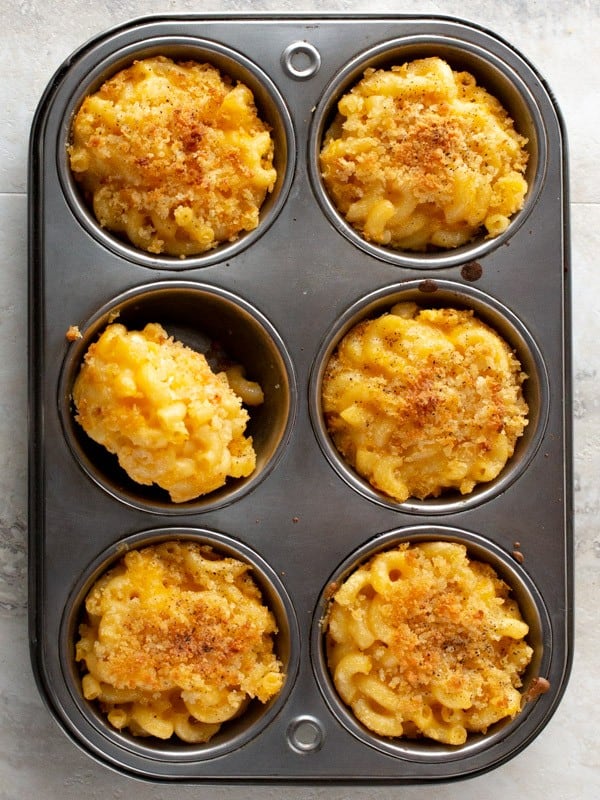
xmin=308 ymin=35 xmax=547 ymax=269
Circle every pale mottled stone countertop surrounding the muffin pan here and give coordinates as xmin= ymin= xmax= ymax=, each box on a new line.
xmin=0 ymin=0 xmax=600 ymax=800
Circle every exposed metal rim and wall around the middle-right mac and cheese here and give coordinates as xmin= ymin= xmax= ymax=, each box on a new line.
xmin=309 ymin=279 xmax=550 ymax=514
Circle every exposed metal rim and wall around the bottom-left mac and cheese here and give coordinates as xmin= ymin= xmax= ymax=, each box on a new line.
xmin=60 ymin=527 xmax=299 ymax=762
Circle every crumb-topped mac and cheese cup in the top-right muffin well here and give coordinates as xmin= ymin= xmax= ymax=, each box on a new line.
xmin=320 ymin=57 xmax=528 ymax=251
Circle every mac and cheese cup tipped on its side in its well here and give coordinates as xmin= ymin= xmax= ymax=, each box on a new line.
xmin=72 ymin=322 xmax=263 ymax=503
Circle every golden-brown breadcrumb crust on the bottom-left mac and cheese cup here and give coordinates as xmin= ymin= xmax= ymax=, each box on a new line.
xmin=82 ymin=543 xmax=275 ymax=692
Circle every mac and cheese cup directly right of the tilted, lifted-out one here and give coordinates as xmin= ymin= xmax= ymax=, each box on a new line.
xmin=322 ymin=302 xmax=528 ymax=502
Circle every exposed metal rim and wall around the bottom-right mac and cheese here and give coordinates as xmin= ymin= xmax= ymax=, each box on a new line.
xmin=311 ymin=525 xmax=552 ymax=763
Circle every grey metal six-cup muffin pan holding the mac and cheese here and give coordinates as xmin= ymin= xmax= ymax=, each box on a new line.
xmin=29 ymin=15 xmax=573 ymax=784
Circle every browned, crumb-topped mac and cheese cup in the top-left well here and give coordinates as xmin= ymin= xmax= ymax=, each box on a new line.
xmin=68 ymin=56 xmax=277 ymax=257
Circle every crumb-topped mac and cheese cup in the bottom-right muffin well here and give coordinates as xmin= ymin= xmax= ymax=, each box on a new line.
xmin=325 ymin=542 xmax=533 ymax=745
